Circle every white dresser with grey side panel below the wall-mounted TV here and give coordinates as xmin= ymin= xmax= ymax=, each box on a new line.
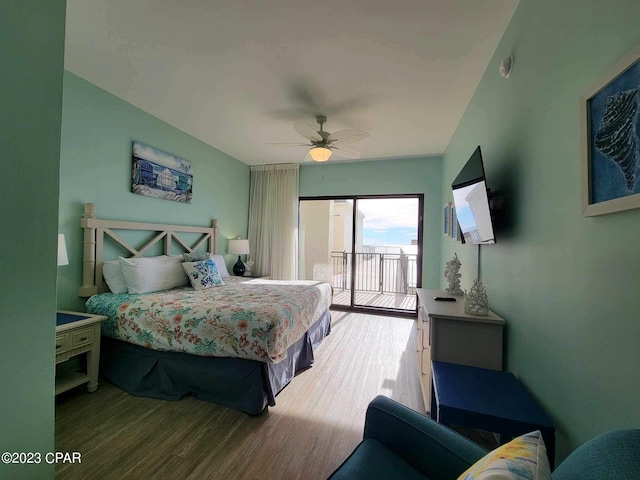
xmin=416 ymin=288 xmax=504 ymax=413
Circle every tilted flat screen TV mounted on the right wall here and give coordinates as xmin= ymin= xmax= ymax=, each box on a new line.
xmin=451 ymin=146 xmax=496 ymax=244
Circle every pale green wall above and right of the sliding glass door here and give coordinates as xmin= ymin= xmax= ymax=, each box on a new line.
xmin=300 ymin=157 xmax=442 ymax=288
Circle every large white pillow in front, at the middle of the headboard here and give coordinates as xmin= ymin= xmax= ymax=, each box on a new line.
xmin=118 ymin=255 xmax=189 ymax=294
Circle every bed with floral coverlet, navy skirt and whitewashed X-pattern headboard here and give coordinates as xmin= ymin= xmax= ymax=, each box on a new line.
xmin=79 ymin=204 xmax=331 ymax=415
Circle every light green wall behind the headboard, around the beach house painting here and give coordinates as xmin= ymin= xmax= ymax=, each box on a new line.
xmin=58 ymin=71 xmax=249 ymax=311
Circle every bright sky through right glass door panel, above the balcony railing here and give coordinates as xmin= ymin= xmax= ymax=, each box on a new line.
xmin=358 ymin=198 xmax=418 ymax=245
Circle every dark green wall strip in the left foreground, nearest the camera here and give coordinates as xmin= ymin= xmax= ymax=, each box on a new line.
xmin=0 ymin=0 xmax=65 ymax=479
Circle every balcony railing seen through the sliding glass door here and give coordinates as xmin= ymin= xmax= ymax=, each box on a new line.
xmin=331 ymin=251 xmax=418 ymax=294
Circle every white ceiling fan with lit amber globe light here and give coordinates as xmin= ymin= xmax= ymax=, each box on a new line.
xmin=272 ymin=115 xmax=370 ymax=162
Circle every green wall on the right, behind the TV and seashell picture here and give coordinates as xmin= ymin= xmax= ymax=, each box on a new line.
xmin=441 ymin=0 xmax=640 ymax=458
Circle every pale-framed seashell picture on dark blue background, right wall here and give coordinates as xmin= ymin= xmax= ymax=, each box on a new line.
xmin=580 ymin=46 xmax=640 ymax=217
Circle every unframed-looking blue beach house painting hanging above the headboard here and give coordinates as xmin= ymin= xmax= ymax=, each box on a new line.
xmin=131 ymin=141 xmax=193 ymax=203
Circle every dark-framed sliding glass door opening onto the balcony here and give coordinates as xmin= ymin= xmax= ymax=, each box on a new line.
xmin=299 ymin=195 xmax=422 ymax=313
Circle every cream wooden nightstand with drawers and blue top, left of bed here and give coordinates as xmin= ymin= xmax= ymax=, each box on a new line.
xmin=56 ymin=310 xmax=107 ymax=395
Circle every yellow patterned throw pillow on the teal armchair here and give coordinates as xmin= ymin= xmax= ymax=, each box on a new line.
xmin=458 ymin=430 xmax=551 ymax=480
